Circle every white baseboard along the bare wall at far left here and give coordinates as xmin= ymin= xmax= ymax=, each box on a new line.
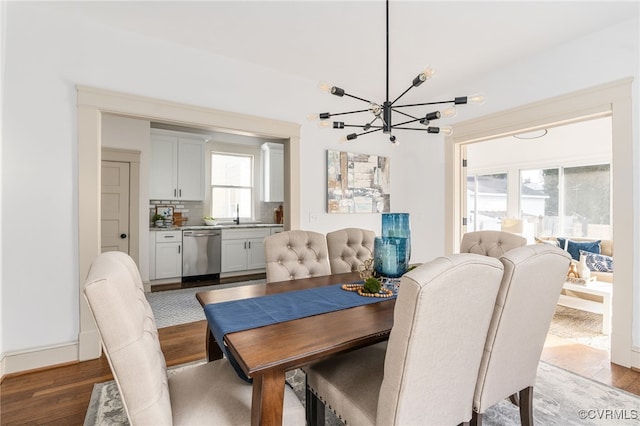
xmin=0 ymin=342 xmax=78 ymax=377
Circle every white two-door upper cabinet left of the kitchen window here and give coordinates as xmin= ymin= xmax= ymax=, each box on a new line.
xmin=149 ymin=133 xmax=205 ymax=201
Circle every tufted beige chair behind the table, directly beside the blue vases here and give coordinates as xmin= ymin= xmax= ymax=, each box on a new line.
xmin=327 ymin=228 xmax=376 ymax=274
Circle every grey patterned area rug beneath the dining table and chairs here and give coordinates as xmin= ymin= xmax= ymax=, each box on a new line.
xmin=84 ymin=362 xmax=640 ymax=426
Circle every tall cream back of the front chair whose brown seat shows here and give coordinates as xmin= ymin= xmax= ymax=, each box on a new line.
xmin=376 ymin=254 xmax=503 ymax=425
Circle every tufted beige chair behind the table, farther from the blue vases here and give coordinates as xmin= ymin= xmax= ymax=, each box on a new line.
xmin=264 ymin=230 xmax=331 ymax=283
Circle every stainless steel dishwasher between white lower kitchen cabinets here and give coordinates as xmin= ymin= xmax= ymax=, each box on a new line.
xmin=182 ymin=229 xmax=222 ymax=282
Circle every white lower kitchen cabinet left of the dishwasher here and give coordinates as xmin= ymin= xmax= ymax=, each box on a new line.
xmin=149 ymin=231 xmax=182 ymax=280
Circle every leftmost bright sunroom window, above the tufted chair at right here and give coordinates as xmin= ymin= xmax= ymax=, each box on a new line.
xmin=467 ymin=173 xmax=507 ymax=231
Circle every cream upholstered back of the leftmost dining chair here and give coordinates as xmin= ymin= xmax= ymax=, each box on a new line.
xmin=84 ymin=251 xmax=172 ymax=425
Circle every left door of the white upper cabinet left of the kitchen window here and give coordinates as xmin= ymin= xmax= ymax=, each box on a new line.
xmin=149 ymin=135 xmax=178 ymax=200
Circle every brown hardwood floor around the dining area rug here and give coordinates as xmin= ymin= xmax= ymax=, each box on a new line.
xmin=0 ymin=321 xmax=640 ymax=425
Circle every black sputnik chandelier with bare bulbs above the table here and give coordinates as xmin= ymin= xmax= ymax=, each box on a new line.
xmin=309 ymin=0 xmax=485 ymax=145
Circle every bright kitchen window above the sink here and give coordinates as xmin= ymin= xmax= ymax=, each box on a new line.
xmin=211 ymin=152 xmax=254 ymax=220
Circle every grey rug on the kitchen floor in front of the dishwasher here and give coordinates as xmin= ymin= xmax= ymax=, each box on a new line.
xmin=145 ymin=279 xmax=266 ymax=328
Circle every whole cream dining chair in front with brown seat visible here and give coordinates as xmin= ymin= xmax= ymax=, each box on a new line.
xmin=304 ymin=254 xmax=503 ymax=425
